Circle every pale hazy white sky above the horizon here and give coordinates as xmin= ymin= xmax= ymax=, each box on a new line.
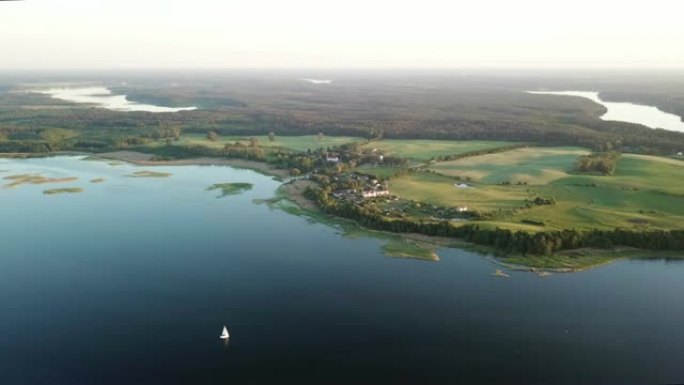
xmin=0 ymin=0 xmax=684 ymax=69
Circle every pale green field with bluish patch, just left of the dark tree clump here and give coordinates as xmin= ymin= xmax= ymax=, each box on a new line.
xmin=430 ymin=147 xmax=589 ymax=184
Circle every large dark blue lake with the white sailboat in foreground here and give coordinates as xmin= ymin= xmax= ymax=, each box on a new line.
xmin=0 ymin=157 xmax=684 ymax=385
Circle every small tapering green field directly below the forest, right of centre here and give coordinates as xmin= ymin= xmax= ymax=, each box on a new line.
xmin=364 ymin=139 xmax=512 ymax=162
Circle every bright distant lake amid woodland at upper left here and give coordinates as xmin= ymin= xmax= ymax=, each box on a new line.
xmin=31 ymin=87 xmax=197 ymax=112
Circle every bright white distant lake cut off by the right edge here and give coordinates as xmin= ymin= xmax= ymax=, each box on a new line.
xmin=529 ymin=91 xmax=684 ymax=132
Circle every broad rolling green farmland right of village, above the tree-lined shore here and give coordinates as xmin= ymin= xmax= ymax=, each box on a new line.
xmin=390 ymin=147 xmax=684 ymax=231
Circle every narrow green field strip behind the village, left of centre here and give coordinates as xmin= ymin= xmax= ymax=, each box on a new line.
xmin=149 ymin=134 xmax=365 ymax=151
